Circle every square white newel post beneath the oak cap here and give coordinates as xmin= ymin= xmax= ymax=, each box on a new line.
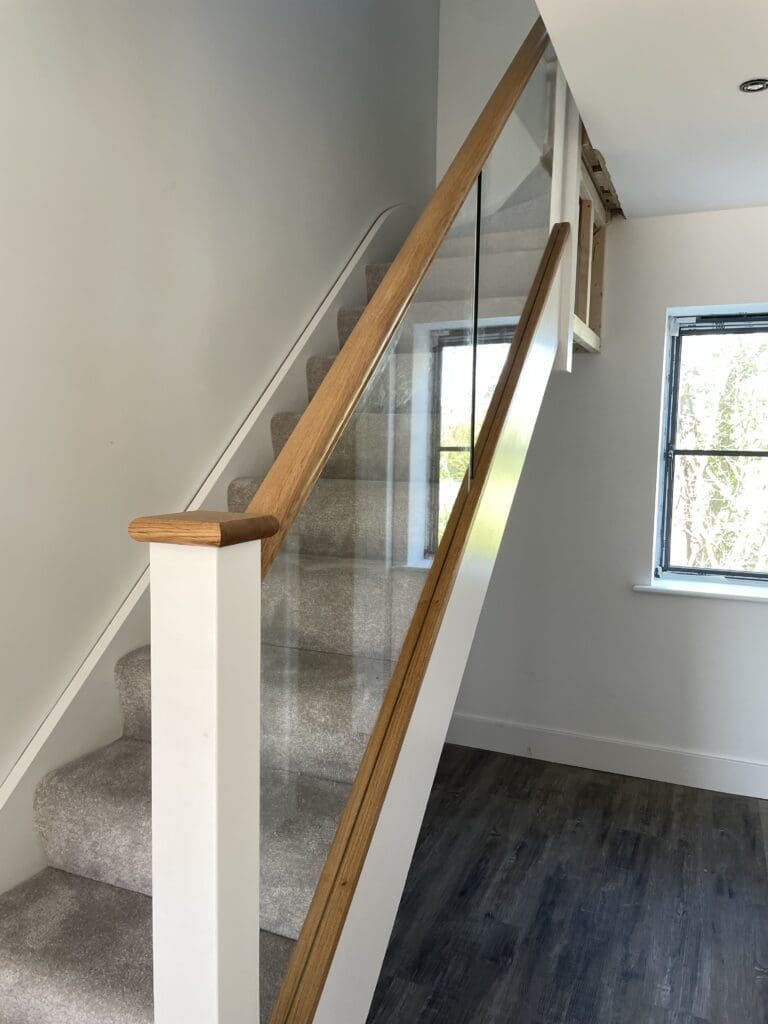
xmin=150 ymin=540 xmax=261 ymax=1024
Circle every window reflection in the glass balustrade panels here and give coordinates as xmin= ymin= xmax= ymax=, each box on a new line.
xmin=425 ymin=321 xmax=517 ymax=555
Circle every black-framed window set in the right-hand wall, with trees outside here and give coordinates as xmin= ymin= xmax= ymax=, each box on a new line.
xmin=656 ymin=314 xmax=768 ymax=580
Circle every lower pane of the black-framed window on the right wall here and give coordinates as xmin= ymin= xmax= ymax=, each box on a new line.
xmin=669 ymin=456 xmax=768 ymax=572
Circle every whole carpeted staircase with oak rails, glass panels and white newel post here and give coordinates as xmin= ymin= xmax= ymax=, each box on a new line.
xmin=0 ymin=22 xmax=585 ymax=1024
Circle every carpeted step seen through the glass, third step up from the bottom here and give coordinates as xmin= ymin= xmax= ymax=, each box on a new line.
xmin=261 ymin=644 xmax=393 ymax=783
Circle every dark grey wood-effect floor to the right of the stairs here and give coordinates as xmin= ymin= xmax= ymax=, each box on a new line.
xmin=369 ymin=746 xmax=768 ymax=1024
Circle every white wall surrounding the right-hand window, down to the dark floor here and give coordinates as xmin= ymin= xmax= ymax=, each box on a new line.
xmin=452 ymin=208 xmax=768 ymax=797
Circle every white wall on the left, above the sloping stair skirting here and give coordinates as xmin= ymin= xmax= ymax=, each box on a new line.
xmin=0 ymin=0 xmax=438 ymax=780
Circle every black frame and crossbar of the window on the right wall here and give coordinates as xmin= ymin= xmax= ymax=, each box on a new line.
xmin=654 ymin=312 xmax=768 ymax=583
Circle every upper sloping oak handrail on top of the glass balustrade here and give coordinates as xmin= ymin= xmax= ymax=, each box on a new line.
xmin=248 ymin=18 xmax=549 ymax=575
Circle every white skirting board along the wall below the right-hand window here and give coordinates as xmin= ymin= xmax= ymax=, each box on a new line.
xmin=447 ymin=712 xmax=768 ymax=800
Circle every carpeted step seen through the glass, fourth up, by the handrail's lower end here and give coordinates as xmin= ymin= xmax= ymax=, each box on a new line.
xmin=261 ymin=552 xmax=434 ymax=659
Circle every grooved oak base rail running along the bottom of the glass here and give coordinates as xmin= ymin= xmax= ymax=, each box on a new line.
xmin=270 ymin=223 xmax=570 ymax=1024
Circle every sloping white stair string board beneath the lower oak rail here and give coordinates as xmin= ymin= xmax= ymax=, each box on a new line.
xmin=314 ymin=253 xmax=559 ymax=1024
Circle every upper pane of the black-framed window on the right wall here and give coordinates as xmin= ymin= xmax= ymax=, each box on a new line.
xmin=675 ymin=333 xmax=768 ymax=452
